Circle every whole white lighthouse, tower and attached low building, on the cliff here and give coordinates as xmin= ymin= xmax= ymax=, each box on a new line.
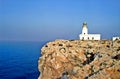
xmin=79 ymin=22 xmax=101 ymax=40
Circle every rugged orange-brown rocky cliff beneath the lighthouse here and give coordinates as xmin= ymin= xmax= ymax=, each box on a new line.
xmin=38 ymin=40 xmax=120 ymax=79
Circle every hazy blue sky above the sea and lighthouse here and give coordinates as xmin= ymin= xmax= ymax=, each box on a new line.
xmin=0 ymin=0 xmax=120 ymax=41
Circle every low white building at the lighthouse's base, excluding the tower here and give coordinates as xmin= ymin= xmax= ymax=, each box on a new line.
xmin=79 ymin=34 xmax=101 ymax=40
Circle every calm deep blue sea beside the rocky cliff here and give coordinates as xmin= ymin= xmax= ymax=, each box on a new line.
xmin=0 ymin=41 xmax=45 ymax=79
